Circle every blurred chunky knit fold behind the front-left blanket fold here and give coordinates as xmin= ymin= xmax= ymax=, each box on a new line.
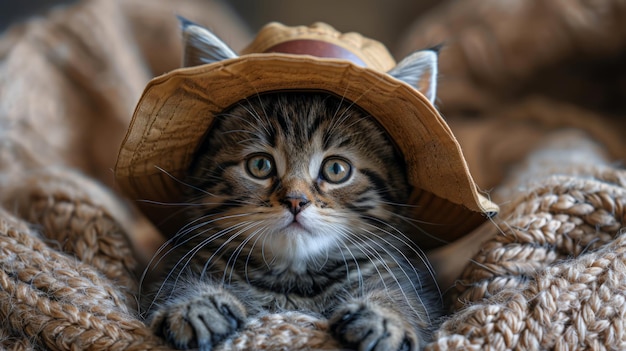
xmin=5 ymin=168 xmax=138 ymax=310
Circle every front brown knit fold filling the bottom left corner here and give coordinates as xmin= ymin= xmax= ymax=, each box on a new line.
xmin=0 ymin=210 xmax=169 ymax=350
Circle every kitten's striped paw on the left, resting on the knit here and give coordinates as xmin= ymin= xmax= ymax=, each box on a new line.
xmin=150 ymin=291 xmax=246 ymax=351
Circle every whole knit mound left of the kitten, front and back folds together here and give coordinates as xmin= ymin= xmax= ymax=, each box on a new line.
xmin=0 ymin=169 xmax=172 ymax=350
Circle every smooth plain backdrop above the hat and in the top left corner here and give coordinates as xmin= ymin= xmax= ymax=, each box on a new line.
xmin=0 ymin=0 xmax=438 ymax=49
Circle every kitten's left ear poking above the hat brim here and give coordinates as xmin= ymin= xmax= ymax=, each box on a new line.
xmin=178 ymin=16 xmax=237 ymax=67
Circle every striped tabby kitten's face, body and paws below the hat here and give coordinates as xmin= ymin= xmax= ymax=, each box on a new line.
xmin=146 ymin=20 xmax=441 ymax=351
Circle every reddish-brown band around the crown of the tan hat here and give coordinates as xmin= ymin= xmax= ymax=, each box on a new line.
xmin=264 ymin=39 xmax=367 ymax=67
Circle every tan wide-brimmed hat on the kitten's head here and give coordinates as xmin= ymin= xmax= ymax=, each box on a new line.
xmin=115 ymin=23 xmax=498 ymax=248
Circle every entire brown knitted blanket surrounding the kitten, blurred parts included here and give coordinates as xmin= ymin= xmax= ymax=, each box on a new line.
xmin=0 ymin=0 xmax=626 ymax=350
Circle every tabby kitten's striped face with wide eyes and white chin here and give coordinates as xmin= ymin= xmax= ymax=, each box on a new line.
xmin=188 ymin=93 xmax=409 ymax=265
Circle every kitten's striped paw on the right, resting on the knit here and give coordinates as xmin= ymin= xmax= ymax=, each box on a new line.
xmin=330 ymin=303 xmax=419 ymax=351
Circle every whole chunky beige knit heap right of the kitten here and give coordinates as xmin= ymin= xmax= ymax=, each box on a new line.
xmin=427 ymin=133 xmax=626 ymax=350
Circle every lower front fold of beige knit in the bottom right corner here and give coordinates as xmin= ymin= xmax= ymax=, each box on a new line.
xmin=427 ymin=235 xmax=626 ymax=350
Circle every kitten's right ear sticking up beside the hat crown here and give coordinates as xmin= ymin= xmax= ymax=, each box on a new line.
xmin=387 ymin=48 xmax=439 ymax=103
